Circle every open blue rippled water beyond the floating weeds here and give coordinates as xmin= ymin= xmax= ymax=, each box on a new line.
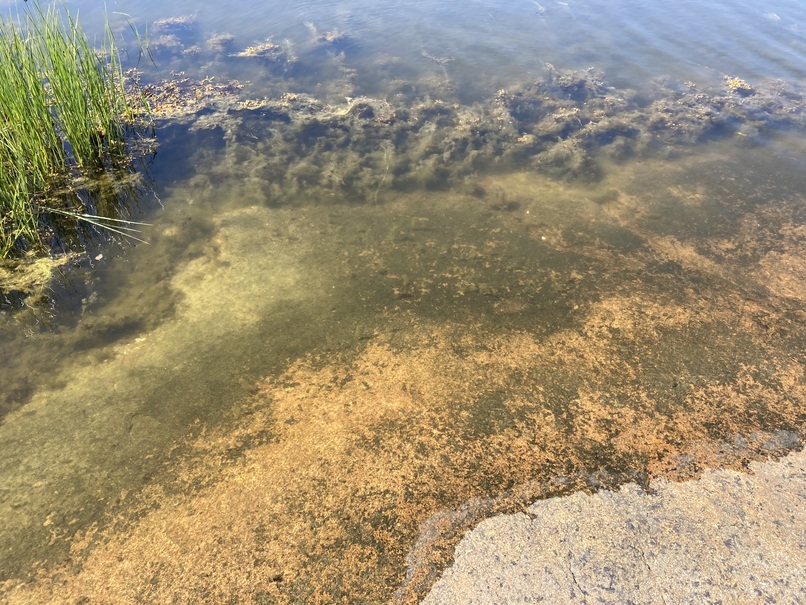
xmin=99 ymin=0 xmax=806 ymax=86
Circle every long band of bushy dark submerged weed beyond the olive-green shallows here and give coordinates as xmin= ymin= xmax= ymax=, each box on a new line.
xmin=147 ymin=65 xmax=806 ymax=198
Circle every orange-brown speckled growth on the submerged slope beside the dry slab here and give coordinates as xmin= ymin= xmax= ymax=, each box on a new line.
xmin=6 ymin=284 xmax=804 ymax=603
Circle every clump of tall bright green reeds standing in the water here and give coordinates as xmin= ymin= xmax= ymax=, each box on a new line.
xmin=0 ymin=3 xmax=149 ymax=258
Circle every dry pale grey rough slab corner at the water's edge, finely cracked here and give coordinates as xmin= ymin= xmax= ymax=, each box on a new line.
xmin=423 ymin=452 xmax=806 ymax=605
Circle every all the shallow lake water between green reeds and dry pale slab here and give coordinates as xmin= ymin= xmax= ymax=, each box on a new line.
xmin=0 ymin=0 xmax=806 ymax=603
